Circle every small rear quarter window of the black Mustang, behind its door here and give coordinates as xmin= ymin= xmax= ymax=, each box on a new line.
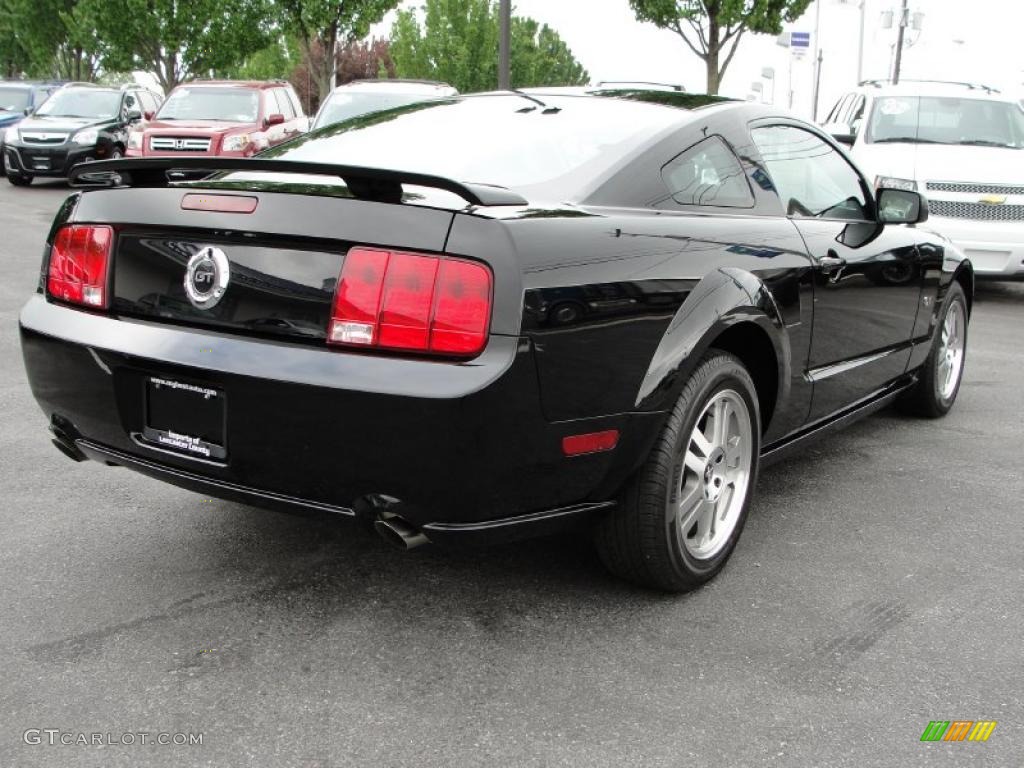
xmin=662 ymin=136 xmax=754 ymax=208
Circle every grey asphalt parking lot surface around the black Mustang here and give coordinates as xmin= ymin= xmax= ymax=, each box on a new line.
xmin=0 ymin=181 xmax=1024 ymax=768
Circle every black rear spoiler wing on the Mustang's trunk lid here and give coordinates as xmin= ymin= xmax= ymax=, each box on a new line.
xmin=68 ymin=157 xmax=528 ymax=206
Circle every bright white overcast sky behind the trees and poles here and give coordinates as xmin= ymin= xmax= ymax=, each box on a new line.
xmin=374 ymin=0 xmax=1024 ymax=118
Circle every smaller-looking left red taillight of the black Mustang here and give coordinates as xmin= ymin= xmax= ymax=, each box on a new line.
xmin=46 ymin=224 xmax=114 ymax=309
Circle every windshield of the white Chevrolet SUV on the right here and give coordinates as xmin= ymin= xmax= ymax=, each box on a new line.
xmin=867 ymin=96 xmax=1024 ymax=150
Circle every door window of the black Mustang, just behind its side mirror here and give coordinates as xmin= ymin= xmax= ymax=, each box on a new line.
xmin=751 ymin=125 xmax=870 ymax=221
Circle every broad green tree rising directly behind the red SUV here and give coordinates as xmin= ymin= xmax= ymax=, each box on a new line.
xmin=76 ymin=0 xmax=272 ymax=91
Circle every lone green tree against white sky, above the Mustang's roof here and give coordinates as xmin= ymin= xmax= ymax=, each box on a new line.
xmin=630 ymin=0 xmax=811 ymax=94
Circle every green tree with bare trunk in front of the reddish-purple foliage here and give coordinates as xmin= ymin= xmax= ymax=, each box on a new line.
xmin=274 ymin=0 xmax=399 ymax=101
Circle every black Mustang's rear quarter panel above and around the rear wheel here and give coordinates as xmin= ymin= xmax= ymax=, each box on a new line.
xmin=447 ymin=208 xmax=812 ymax=442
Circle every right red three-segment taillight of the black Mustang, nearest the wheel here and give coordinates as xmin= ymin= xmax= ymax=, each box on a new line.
xmin=328 ymin=248 xmax=490 ymax=356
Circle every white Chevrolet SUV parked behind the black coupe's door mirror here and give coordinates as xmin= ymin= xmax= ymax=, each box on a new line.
xmin=823 ymin=80 xmax=1024 ymax=279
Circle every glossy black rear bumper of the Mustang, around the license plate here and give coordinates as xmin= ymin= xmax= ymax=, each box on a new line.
xmin=20 ymin=295 xmax=663 ymax=543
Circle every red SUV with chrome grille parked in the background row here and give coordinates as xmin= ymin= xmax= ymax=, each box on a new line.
xmin=125 ymin=80 xmax=309 ymax=158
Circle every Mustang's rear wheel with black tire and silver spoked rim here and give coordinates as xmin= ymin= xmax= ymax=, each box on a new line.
xmin=594 ymin=350 xmax=761 ymax=592
